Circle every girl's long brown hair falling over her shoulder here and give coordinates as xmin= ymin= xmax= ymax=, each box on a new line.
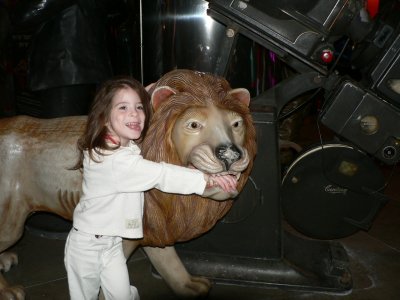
xmin=72 ymin=77 xmax=152 ymax=170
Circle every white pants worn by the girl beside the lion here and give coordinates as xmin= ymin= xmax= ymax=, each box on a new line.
xmin=64 ymin=229 xmax=140 ymax=300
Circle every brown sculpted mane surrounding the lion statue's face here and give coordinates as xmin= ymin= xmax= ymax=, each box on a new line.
xmin=142 ymin=70 xmax=256 ymax=247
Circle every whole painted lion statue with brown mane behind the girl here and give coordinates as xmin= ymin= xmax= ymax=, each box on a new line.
xmin=0 ymin=70 xmax=256 ymax=299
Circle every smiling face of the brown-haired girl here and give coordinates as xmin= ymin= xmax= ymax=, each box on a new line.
xmin=106 ymin=87 xmax=146 ymax=147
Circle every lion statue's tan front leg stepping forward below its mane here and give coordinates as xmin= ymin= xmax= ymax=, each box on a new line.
xmin=144 ymin=246 xmax=211 ymax=298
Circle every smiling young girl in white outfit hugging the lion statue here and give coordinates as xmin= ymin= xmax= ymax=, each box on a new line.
xmin=65 ymin=78 xmax=236 ymax=300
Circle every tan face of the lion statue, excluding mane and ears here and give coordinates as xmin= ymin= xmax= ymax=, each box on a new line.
xmin=171 ymin=105 xmax=249 ymax=200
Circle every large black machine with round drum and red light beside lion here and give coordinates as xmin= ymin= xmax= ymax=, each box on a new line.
xmin=178 ymin=0 xmax=400 ymax=292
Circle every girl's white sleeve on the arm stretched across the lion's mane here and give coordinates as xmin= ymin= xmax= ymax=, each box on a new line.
xmin=112 ymin=151 xmax=206 ymax=195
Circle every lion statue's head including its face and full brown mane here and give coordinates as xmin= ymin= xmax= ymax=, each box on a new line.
xmin=142 ymin=70 xmax=256 ymax=246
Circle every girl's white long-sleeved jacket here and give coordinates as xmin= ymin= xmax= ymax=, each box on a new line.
xmin=73 ymin=142 xmax=206 ymax=238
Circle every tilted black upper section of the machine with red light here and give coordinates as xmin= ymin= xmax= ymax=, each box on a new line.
xmin=209 ymin=0 xmax=400 ymax=164
